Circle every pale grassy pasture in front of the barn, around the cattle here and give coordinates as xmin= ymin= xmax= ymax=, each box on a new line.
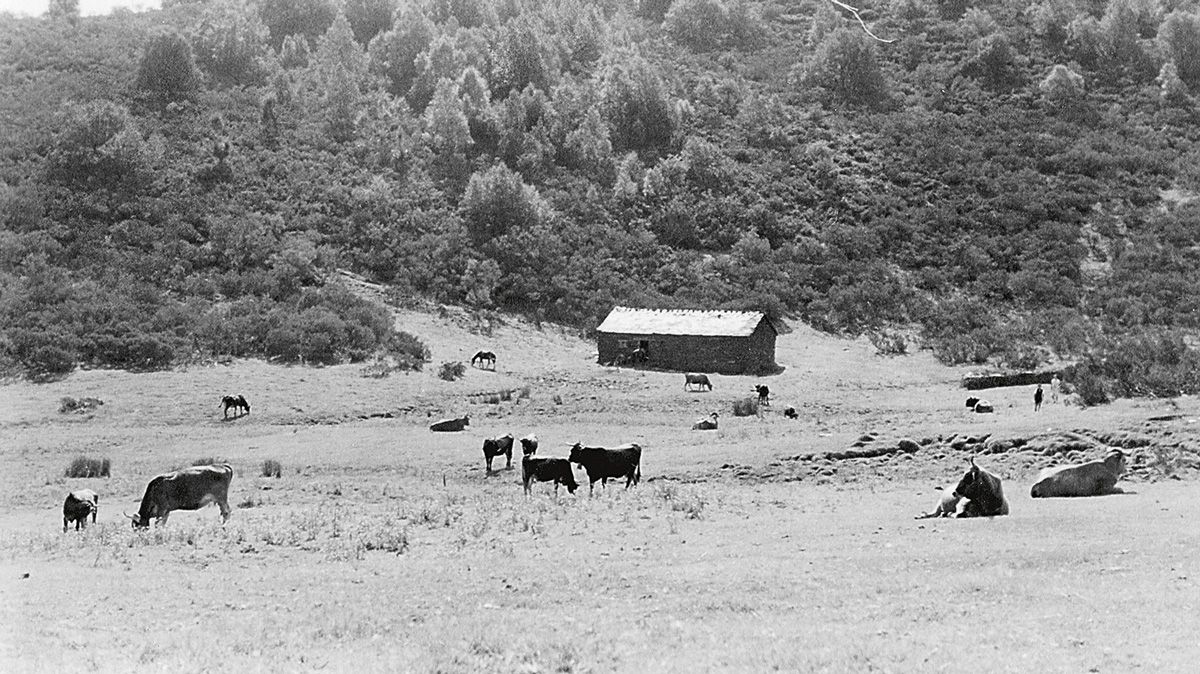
xmin=0 ymin=312 xmax=1200 ymax=672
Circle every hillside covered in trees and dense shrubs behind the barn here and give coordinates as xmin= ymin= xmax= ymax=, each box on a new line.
xmin=0 ymin=0 xmax=1200 ymax=402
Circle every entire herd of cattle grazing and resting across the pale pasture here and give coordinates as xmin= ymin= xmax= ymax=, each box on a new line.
xmin=51 ymin=374 xmax=1126 ymax=532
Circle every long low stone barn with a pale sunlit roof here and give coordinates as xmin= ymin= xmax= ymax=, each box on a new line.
xmin=596 ymin=307 xmax=778 ymax=374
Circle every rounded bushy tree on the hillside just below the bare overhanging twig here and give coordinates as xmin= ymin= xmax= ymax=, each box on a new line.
xmin=804 ymin=28 xmax=888 ymax=107
